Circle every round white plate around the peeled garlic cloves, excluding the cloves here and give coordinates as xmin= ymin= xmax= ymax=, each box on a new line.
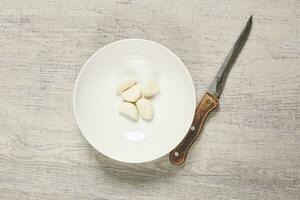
xmin=73 ymin=39 xmax=196 ymax=163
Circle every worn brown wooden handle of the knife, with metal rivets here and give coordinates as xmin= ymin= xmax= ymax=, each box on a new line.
xmin=169 ymin=93 xmax=219 ymax=166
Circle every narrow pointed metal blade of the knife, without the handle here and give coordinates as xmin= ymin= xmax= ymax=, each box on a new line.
xmin=207 ymin=15 xmax=252 ymax=98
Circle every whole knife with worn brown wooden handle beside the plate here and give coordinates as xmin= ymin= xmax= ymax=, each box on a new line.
xmin=169 ymin=15 xmax=252 ymax=166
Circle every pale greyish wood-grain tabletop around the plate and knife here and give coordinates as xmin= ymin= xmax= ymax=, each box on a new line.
xmin=0 ymin=0 xmax=300 ymax=200
